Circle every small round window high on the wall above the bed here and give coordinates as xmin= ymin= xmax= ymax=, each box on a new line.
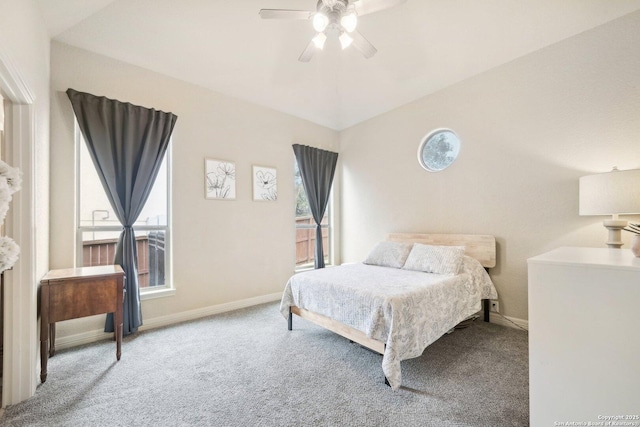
xmin=418 ymin=129 xmax=460 ymax=172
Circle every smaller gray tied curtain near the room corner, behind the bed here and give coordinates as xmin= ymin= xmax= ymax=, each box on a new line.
xmin=293 ymin=144 xmax=338 ymax=268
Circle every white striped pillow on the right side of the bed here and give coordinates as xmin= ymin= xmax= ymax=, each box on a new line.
xmin=402 ymin=243 xmax=464 ymax=274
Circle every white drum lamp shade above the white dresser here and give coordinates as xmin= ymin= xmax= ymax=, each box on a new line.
xmin=580 ymin=169 xmax=640 ymax=215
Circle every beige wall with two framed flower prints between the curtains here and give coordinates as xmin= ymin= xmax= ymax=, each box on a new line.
xmin=51 ymin=42 xmax=338 ymax=337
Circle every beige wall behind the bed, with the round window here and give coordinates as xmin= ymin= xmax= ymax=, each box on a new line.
xmin=340 ymin=13 xmax=640 ymax=319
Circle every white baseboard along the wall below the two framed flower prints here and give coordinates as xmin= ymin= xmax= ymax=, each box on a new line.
xmin=56 ymin=292 xmax=282 ymax=350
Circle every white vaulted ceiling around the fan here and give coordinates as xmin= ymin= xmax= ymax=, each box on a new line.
xmin=37 ymin=0 xmax=640 ymax=130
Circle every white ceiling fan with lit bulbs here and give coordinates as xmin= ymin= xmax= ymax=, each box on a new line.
xmin=260 ymin=0 xmax=406 ymax=62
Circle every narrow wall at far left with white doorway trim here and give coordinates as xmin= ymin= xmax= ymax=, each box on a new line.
xmin=0 ymin=0 xmax=50 ymax=406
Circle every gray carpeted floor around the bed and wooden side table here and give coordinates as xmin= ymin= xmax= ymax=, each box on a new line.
xmin=0 ymin=303 xmax=529 ymax=427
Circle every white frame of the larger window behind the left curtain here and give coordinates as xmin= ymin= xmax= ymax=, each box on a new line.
xmin=74 ymin=120 xmax=175 ymax=300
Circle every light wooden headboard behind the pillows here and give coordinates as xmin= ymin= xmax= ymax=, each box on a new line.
xmin=387 ymin=233 xmax=496 ymax=268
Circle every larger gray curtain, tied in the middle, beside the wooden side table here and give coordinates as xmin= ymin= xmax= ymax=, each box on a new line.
xmin=67 ymin=89 xmax=178 ymax=335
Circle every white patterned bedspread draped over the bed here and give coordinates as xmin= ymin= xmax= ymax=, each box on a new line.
xmin=280 ymin=256 xmax=497 ymax=390
